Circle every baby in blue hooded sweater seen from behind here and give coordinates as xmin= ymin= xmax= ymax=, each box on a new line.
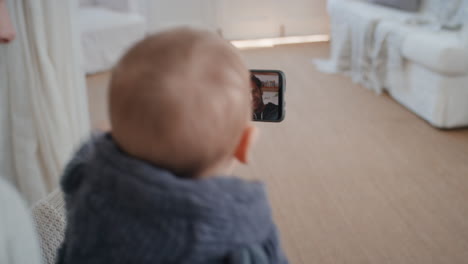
xmin=58 ymin=28 xmax=287 ymax=264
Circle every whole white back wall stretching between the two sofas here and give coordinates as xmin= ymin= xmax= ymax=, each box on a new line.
xmin=146 ymin=0 xmax=329 ymax=39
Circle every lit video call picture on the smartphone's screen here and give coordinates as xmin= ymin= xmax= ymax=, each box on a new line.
xmin=250 ymin=72 xmax=279 ymax=120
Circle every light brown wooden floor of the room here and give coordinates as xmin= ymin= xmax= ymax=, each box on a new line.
xmin=88 ymin=44 xmax=468 ymax=264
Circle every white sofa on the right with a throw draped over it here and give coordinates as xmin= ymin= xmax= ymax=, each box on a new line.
xmin=328 ymin=0 xmax=468 ymax=128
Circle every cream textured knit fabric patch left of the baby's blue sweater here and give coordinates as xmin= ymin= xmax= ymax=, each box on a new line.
xmin=32 ymin=189 xmax=65 ymax=264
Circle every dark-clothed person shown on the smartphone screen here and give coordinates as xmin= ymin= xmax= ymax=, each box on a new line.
xmin=250 ymin=74 xmax=278 ymax=120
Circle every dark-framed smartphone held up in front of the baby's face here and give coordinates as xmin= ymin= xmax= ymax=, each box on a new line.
xmin=250 ymin=70 xmax=286 ymax=122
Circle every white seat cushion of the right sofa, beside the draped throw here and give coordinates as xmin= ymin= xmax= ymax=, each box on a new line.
xmin=401 ymin=29 xmax=468 ymax=75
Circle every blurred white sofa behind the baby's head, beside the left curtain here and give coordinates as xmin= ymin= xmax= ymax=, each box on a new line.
xmin=78 ymin=0 xmax=147 ymax=74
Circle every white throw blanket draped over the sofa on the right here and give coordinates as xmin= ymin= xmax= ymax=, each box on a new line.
xmin=313 ymin=0 xmax=468 ymax=94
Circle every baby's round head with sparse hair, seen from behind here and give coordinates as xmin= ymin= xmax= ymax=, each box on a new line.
xmin=109 ymin=28 xmax=255 ymax=177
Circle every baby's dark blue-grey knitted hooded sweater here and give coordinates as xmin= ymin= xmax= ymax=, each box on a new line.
xmin=58 ymin=134 xmax=287 ymax=264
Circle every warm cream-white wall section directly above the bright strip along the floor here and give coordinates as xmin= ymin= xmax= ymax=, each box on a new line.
xmin=218 ymin=0 xmax=328 ymax=39
